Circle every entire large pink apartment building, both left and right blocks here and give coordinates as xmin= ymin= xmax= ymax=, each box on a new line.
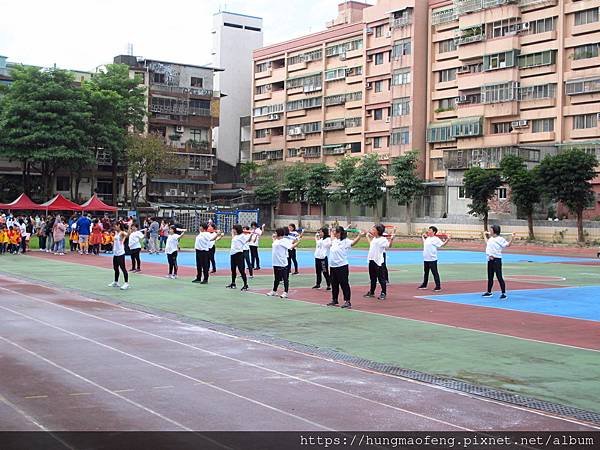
xmin=252 ymin=0 xmax=600 ymax=216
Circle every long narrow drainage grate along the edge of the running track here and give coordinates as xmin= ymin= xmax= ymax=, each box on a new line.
xmin=10 ymin=275 xmax=600 ymax=425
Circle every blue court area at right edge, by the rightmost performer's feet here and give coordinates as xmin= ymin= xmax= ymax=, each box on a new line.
xmin=424 ymin=282 xmax=600 ymax=322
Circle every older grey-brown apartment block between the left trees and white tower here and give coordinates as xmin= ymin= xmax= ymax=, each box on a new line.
xmin=115 ymin=55 xmax=220 ymax=204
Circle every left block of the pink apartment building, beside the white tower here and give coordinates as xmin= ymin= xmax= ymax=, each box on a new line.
xmin=252 ymin=0 xmax=428 ymax=176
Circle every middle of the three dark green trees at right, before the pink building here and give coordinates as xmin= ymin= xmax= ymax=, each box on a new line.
xmin=500 ymin=155 xmax=542 ymax=240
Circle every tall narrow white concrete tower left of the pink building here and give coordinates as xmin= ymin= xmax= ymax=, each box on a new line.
xmin=212 ymin=11 xmax=263 ymax=183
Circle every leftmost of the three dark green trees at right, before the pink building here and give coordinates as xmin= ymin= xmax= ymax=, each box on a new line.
xmin=464 ymin=167 xmax=502 ymax=231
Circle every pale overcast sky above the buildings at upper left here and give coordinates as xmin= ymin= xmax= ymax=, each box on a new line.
xmin=0 ymin=0 xmax=366 ymax=71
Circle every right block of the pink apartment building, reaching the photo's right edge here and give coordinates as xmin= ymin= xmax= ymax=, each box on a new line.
xmin=425 ymin=0 xmax=600 ymax=216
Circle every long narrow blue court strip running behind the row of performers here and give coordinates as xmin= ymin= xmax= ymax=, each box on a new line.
xmin=125 ymin=249 xmax=590 ymax=269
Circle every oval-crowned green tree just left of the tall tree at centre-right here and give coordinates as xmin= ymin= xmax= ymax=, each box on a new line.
xmin=352 ymin=154 xmax=385 ymax=222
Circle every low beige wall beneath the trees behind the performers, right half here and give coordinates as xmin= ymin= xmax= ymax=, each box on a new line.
xmin=275 ymin=215 xmax=600 ymax=243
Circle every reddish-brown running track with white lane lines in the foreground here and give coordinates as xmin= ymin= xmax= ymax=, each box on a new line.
xmin=0 ymin=276 xmax=592 ymax=430
